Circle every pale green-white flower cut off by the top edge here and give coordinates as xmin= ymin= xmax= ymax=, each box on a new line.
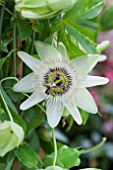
xmin=15 ymin=0 xmax=77 ymax=19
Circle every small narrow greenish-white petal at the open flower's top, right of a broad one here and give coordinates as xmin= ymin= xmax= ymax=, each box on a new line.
xmin=58 ymin=42 xmax=69 ymax=59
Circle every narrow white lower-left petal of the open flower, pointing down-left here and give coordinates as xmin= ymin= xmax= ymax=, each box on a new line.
xmin=20 ymin=90 xmax=46 ymax=110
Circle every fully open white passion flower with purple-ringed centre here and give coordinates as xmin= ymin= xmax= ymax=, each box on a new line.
xmin=13 ymin=41 xmax=109 ymax=127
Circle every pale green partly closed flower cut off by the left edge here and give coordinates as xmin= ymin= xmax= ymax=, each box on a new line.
xmin=0 ymin=121 xmax=24 ymax=157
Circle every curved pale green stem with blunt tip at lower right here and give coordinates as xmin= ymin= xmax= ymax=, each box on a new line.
xmin=80 ymin=137 xmax=106 ymax=154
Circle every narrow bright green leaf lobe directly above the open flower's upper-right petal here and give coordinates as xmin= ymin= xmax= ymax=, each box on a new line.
xmin=58 ymin=25 xmax=85 ymax=59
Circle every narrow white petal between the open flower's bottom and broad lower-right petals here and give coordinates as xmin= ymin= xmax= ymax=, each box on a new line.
xmin=65 ymin=100 xmax=82 ymax=125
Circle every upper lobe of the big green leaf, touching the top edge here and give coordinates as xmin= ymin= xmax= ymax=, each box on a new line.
xmin=64 ymin=0 xmax=104 ymax=21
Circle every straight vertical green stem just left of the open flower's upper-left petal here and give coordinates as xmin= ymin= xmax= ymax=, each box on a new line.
xmin=13 ymin=11 xmax=17 ymax=77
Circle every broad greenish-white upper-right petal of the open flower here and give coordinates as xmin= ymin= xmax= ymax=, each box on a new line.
xmin=72 ymin=54 xmax=99 ymax=74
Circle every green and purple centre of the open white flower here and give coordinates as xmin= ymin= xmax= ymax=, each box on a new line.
xmin=43 ymin=67 xmax=72 ymax=96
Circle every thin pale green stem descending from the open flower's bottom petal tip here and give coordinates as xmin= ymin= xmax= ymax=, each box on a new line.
xmin=52 ymin=128 xmax=57 ymax=166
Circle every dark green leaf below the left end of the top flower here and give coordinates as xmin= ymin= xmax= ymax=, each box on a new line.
xmin=14 ymin=19 xmax=32 ymax=41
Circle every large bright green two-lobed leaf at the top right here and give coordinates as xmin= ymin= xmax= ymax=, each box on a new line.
xmin=63 ymin=0 xmax=104 ymax=53
